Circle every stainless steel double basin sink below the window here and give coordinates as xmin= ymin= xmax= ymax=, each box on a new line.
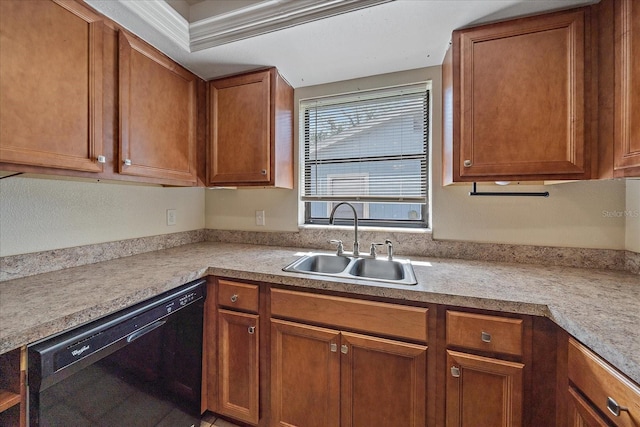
xmin=283 ymin=253 xmax=418 ymax=285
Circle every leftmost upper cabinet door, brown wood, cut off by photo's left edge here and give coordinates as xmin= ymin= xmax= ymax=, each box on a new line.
xmin=0 ymin=0 xmax=104 ymax=173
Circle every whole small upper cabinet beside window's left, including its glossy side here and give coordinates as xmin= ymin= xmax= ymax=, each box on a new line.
xmin=207 ymin=68 xmax=293 ymax=188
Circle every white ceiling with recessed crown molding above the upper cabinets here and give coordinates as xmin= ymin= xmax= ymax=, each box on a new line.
xmin=85 ymin=0 xmax=595 ymax=87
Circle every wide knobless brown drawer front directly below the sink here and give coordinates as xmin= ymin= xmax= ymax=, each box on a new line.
xmin=271 ymin=289 xmax=429 ymax=342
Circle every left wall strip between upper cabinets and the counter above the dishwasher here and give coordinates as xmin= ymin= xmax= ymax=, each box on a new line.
xmin=0 ymin=176 xmax=205 ymax=256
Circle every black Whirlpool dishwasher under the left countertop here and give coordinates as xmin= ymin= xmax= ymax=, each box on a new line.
xmin=27 ymin=280 xmax=206 ymax=427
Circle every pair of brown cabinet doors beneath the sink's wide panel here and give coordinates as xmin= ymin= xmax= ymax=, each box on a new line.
xmin=271 ymin=319 xmax=427 ymax=427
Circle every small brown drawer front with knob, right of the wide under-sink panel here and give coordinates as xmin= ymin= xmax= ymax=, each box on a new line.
xmin=447 ymin=311 xmax=523 ymax=356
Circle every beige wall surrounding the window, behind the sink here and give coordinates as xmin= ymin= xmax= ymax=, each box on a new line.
xmin=206 ymin=67 xmax=640 ymax=249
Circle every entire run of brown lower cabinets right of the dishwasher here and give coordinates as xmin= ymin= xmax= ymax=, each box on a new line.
xmin=203 ymin=278 xmax=640 ymax=427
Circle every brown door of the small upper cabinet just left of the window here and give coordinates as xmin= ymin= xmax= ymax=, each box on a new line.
xmin=209 ymin=70 xmax=272 ymax=185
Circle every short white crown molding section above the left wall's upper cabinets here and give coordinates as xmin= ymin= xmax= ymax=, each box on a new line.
xmin=119 ymin=0 xmax=191 ymax=52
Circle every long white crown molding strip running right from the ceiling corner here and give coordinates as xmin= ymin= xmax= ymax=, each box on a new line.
xmin=190 ymin=0 xmax=394 ymax=52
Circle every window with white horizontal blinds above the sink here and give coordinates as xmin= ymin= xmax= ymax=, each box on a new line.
xmin=300 ymin=83 xmax=429 ymax=227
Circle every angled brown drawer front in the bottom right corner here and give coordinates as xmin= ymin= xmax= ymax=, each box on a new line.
xmin=568 ymin=338 xmax=640 ymax=427
